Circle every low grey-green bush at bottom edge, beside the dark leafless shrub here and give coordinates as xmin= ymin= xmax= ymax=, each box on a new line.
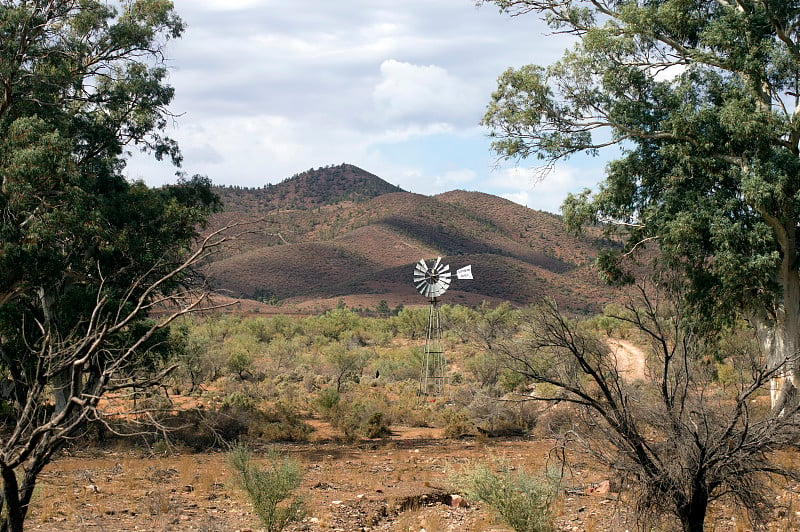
xmin=456 ymin=463 xmax=556 ymax=532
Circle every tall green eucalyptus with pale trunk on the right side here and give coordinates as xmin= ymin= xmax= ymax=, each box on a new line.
xmin=484 ymin=0 xmax=800 ymax=410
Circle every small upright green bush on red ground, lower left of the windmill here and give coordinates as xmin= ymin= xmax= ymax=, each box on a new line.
xmin=228 ymin=445 xmax=305 ymax=532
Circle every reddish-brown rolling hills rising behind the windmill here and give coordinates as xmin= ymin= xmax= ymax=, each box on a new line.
xmin=207 ymin=165 xmax=613 ymax=312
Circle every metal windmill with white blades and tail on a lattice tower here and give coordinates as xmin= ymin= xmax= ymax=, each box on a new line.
xmin=414 ymin=257 xmax=472 ymax=396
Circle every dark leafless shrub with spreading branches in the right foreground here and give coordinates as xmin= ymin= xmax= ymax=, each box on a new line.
xmin=503 ymin=287 xmax=800 ymax=532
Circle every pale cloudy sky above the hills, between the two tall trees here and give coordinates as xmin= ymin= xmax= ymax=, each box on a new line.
xmin=127 ymin=0 xmax=605 ymax=213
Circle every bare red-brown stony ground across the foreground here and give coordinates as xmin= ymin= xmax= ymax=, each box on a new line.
xmin=28 ymin=429 xmax=800 ymax=532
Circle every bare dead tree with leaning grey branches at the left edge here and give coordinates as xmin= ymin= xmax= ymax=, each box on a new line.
xmin=0 ymin=227 xmax=241 ymax=530
